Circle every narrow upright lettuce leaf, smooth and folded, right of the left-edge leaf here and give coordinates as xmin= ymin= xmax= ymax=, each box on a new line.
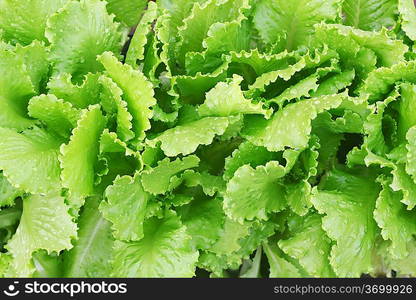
xmin=59 ymin=105 xmax=105 ymax=210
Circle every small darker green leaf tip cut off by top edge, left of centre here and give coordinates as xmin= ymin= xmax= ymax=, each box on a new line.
xmin=106 ymin=0 xmax=148 ymax=27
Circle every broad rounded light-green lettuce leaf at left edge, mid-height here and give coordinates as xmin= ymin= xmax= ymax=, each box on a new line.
xmin=0 ymin=127 xmax=61 ymax=193
